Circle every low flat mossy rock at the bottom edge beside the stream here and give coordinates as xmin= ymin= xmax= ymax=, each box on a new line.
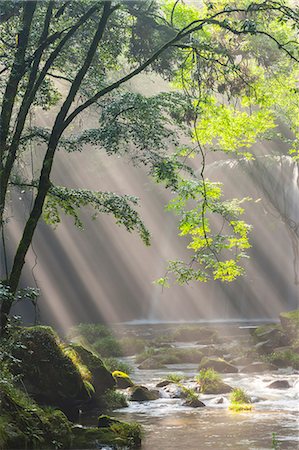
xmin=72 ymin=421 xmax=142 ymax=450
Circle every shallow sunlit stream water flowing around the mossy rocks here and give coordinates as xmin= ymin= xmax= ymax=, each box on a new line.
xmin=106 ymin=326 xmax=299 ymax=450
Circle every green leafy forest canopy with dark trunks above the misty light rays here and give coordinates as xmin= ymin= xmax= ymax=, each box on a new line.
xmin=0 ymin=0 xmax=299 ymax=328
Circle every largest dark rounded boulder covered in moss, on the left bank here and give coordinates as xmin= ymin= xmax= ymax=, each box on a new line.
xmin=11 ymin=326 xmax=90 ymax=415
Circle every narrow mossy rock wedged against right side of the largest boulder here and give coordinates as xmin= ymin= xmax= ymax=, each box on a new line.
xmin=71 ymin=344 xmax=115 ymax=395
